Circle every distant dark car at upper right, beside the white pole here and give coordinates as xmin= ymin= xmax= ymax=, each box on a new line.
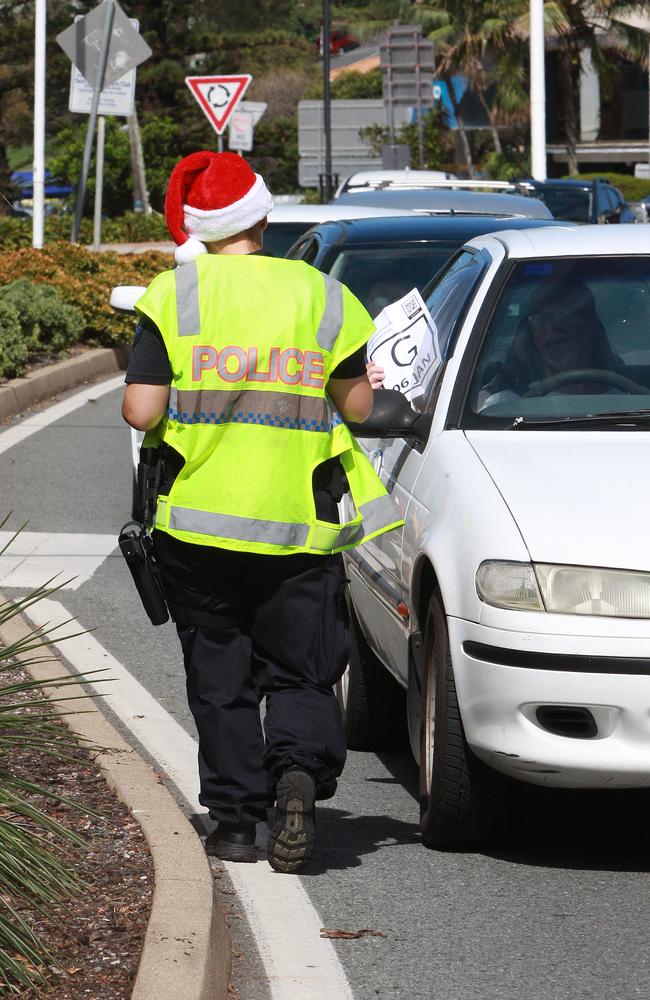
xmin=524 ymin=177 xmax=636 ymax=224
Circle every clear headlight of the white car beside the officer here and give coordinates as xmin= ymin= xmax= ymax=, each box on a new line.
xmin=476 ymin=560 xmax=650 ymax=618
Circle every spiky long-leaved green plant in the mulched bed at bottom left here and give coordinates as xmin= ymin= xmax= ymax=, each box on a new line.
xmin=0 ymin=518 xmax=107 ymax=995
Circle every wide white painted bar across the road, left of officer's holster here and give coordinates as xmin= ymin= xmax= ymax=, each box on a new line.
xmin=0 ymin=531 xmax=117 ymax=590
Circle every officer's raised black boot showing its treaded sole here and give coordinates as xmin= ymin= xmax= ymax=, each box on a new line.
xmin=268 ymin=768 xmax=316 ymax=874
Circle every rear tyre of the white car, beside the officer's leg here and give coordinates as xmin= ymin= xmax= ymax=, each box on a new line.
xmin=336 ymin=609 xmax=408 ymax=751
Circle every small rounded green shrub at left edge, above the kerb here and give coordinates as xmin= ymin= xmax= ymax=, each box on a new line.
xmin=0 ymin=278 xmax=84 ymax=353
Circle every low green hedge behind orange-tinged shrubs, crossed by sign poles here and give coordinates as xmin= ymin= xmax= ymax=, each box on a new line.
xmin=0 ymin=212 xmax=170 ymax=250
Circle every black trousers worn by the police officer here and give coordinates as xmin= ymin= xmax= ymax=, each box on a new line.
xmin=154 ymin=532 xmax=349 ymax=823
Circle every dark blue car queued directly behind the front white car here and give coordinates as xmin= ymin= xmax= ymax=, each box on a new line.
xmin=286 ymin=215 xmax=562 ymax=317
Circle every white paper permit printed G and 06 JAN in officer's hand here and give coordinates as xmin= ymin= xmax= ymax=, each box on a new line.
xmin=367 ymin=288 xmax=441 ymax=402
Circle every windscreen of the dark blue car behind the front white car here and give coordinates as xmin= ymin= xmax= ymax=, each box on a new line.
xmin=330 ymin=242 xmax=460 ymax=317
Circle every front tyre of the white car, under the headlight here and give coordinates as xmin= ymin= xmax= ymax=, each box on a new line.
xmin=420 ymin=594 xmax=512 ymax=851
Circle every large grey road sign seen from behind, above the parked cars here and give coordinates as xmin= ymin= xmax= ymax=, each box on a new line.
xmin=298 ymin=98 xmax=409 ymax=188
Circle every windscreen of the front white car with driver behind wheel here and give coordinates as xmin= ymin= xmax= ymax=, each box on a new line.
xmin=462 ymin=256 xmax=650 ymax=427
